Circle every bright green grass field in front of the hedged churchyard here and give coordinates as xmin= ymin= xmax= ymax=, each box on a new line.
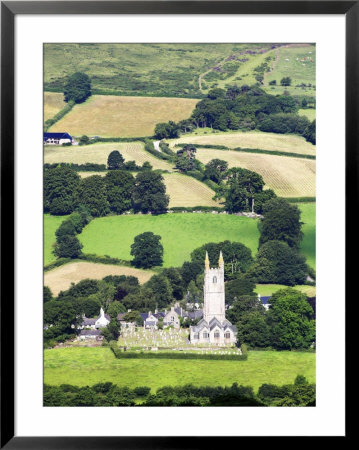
xmin=44 ymin=347 xmax=315 ymax=391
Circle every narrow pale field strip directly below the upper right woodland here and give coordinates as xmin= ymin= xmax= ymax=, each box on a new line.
xmin=168 ymin=130 xmax=315 ymax=159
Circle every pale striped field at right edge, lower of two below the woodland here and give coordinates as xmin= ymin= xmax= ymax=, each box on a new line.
xmin=197 ymin=148 xmax=315 ymax=197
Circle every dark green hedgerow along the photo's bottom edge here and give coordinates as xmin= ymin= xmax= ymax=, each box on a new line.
xmin=44 ymin=375 xmax=315 ymax=406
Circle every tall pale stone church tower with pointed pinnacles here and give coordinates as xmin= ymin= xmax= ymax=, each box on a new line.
xmin=203 ymin=251 xmax=225 ymax=323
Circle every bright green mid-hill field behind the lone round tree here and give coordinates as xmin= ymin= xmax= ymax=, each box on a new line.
xmin=79 ymin=213 xmax=259 ymax=267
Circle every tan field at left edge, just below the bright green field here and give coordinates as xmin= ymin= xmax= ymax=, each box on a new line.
xmin=44 ymin=261 xmax=154 ymax=295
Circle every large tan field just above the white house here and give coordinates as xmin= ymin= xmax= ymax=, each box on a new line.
xmin=49 ymin=95 xmax=198 ymax=137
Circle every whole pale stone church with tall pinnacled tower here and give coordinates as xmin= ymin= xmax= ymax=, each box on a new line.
xmin=190 ymin=252 xmax=237 ymax=345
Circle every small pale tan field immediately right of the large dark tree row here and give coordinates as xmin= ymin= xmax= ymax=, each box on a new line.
xmin=163 ymin=173 xmax=219 ymax=208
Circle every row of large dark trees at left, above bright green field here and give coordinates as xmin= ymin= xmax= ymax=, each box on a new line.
xmin=44 ymin=156 xmax=169 ymax=217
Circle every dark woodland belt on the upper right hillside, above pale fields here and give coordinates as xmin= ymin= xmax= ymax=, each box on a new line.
xmin=155 ymin=85 xmax=316 ymax=144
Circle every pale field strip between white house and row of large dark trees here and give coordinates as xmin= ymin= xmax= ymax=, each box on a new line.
xmin=44 ymin=142 xmax=172 ymax=171
